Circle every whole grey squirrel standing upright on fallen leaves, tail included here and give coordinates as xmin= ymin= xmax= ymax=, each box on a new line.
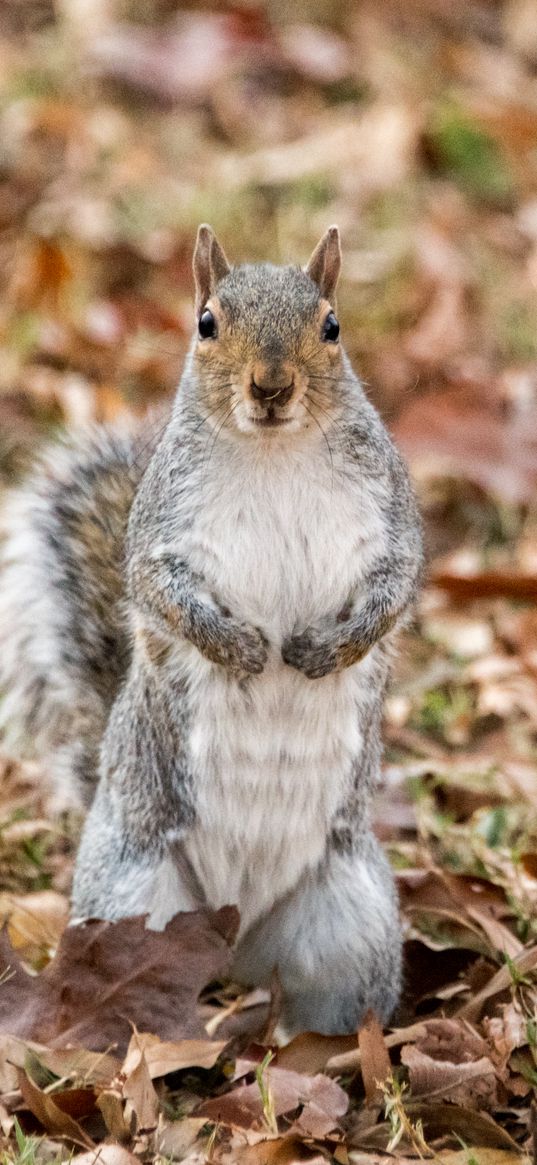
xmin=0 ymin=225 xmax=422 ymax=1033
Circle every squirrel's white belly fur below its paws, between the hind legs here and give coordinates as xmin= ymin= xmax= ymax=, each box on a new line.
xmin=180 ymin=659 xmax=370 ymax=931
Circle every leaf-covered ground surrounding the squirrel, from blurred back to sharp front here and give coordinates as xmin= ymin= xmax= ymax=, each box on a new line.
xmin=0 ymin=0 xmax=537 ymax=1165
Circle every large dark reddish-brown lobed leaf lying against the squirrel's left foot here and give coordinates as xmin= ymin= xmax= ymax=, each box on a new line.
xmin=0 ymin=906 xmax=238 ymax=1051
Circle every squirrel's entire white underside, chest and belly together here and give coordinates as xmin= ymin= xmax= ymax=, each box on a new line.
xmin=175 ymin=438 xmax=382 ymax=927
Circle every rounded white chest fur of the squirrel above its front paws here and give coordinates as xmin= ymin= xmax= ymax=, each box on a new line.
xmin=189 ymin=440 xmax=383 ymax=647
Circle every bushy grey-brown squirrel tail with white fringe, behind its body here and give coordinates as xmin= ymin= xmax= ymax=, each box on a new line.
xmin=0 ymin=425 xmax=156 ymax=806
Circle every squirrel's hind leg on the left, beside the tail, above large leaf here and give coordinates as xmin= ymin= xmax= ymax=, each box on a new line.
xmin=72 ymin=659 xmax=203 ymax=930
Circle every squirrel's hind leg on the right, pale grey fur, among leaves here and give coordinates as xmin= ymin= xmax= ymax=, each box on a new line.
xmin=234 ymin=835 xmax=401 ymax=1036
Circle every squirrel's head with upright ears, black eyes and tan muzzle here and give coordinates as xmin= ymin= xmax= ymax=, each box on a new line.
xmin=193 ymin=225 xmax=341 ymax=433
